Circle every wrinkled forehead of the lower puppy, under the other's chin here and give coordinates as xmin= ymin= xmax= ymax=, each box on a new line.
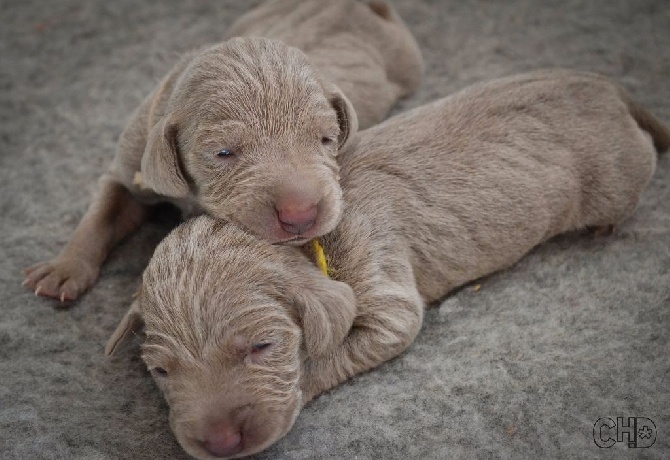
xmin=138 ymin=216 xmax=302 ymax=353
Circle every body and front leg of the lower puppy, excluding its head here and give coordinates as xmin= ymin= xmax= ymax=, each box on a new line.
xmin=303 ymin=70 xmax=670 ymax=399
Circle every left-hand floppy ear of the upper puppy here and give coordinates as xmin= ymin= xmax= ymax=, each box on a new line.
xmin=141 ymin=117 xmax=189 ymax=198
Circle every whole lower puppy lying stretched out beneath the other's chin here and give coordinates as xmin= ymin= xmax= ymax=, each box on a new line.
xmin=106 ymin=70 xmax=670 ymax=459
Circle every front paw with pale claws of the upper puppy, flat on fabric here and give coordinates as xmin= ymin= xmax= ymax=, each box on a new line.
xmin=23 ymin=257 xmax=100 ymax=302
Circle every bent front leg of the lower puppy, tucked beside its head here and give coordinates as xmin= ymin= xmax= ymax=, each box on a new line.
xmin=301 ymin=248 xmax=425 ymax=403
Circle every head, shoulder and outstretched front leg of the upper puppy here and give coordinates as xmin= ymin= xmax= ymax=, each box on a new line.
xmin=24 ymin=38 xmax=357 ymax=301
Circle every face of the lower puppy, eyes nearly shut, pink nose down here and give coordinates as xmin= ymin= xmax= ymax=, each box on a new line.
xmin=140 ymin=279 xmax=301 ymax=458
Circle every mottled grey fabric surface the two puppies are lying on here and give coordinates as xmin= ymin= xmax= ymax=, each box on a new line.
xmin=0 ymin=0 xmax=670 ymax=460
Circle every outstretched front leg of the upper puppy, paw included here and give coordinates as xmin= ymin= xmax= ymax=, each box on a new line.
xmin=23 ymin=175 xmax=147 ymax=302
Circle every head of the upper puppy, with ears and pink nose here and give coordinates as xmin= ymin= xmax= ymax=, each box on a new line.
xmin=142 ymin=37 xmax=358 ymax=243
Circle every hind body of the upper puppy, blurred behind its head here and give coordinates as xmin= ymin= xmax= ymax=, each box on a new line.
xmin=229 ymin=0 xmax=423 ymax=128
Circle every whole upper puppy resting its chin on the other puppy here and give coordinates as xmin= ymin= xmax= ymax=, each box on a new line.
xmin=24 ymin=0 xmax=423 ymax=301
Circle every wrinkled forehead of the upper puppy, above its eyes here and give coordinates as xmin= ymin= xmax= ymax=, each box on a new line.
xmin=179 ymin=39 xmax=336 ymax=132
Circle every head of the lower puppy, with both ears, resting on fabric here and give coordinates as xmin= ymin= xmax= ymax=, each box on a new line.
xmin=107 ymin=216 xmax=355 ymax=459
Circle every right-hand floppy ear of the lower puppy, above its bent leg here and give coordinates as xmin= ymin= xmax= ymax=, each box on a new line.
xmin=294 ymin=276 xmax=356 ymax=358
